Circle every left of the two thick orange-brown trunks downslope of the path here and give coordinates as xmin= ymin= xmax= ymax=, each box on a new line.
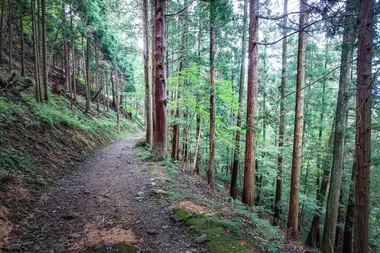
xmin=242 ymin=0 xmax=259 ymax=207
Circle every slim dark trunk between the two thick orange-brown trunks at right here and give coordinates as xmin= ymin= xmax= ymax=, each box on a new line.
xmin=273 ymin=0 xmax=288 ymax=226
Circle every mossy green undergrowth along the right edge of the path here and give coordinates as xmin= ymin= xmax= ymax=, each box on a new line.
xmin=136 ymin=147 xmax=282 ymax=253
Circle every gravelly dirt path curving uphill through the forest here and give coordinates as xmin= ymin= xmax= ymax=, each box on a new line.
xmin=9 ymin=135 xmax=199 ymax=253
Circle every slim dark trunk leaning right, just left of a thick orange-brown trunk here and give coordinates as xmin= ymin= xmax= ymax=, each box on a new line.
xmin=230 ymin=0 xmax=248 ymax=199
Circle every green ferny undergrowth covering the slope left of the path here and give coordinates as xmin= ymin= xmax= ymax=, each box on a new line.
xmin=0 ymin=88 xmax=141 ymax=189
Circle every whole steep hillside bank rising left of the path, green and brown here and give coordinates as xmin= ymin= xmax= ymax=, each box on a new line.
xmin=0 ymin=71 xmax=141 ymax=245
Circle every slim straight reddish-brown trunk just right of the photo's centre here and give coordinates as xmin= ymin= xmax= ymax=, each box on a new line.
xmin=207 ymin=0 xmax=215 ymax=189
